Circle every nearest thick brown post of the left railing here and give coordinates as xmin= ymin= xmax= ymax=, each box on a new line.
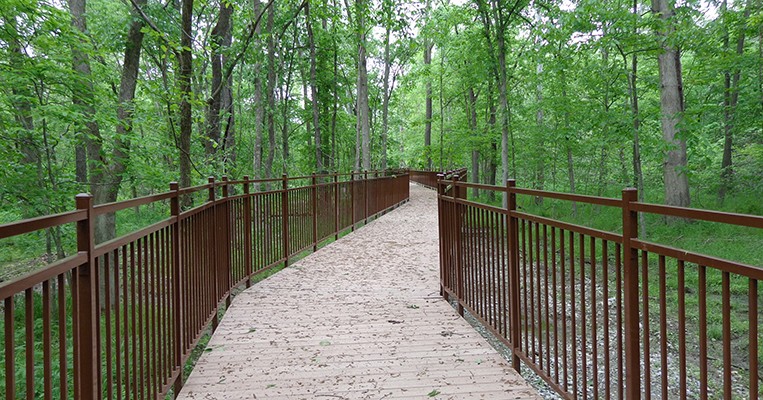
xmin=75 ymin=194 xmax=100 ymax=400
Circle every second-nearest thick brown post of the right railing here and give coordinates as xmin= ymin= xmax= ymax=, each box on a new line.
xmin=506 ymin=179 xmax=520 ymax=372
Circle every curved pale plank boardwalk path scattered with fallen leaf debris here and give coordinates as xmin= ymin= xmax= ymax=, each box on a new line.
xmin=180 ymin=186 xmax=539 ymax=399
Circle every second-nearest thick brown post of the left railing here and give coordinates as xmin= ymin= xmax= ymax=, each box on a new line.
xmin=170 ymin=182 xmax=185 ymax=398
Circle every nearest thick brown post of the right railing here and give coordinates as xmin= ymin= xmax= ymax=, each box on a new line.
xmin=622 ymin=188 xmax=648 ymax=400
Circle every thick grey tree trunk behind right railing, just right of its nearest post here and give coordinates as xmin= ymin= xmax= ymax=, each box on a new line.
xmin=652 ymin=0 xmax=691 ymax=207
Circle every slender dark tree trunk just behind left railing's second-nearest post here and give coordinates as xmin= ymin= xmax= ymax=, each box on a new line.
xmin=177 ymin=0 xmax=193 ymax=207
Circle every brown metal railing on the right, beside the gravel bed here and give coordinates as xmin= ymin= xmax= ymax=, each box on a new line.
xmin=438 ymin=175 xmax=763 ymax=399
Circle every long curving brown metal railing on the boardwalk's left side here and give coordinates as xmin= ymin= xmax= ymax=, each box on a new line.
xmin=0 ymin=172 xmax=409 ymax=400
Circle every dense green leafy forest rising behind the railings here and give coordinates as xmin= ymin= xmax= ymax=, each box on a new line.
xmin=0 ymin=0 xmax=763 ymax=247
